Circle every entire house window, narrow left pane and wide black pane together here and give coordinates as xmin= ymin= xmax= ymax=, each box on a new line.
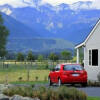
xmin=89 ymin=49 xmax=98 ymax=66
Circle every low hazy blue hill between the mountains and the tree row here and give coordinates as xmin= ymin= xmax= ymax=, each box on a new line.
xmin=7 ymin=38 xmax=74 ymax=53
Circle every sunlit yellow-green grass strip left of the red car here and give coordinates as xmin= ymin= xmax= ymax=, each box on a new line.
xmin=0 ymin=69 xmax=49 ymax=83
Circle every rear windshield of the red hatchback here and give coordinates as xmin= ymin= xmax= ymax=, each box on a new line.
xmin=63 ymin=65 xmax=84 ymax=71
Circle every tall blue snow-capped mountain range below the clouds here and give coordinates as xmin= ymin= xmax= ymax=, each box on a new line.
xmin=0 ymin=0 xmax=100 ymax=43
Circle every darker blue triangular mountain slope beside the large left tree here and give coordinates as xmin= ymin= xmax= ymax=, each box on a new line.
xmin=2 ymin=13 xmax=40 ymax=38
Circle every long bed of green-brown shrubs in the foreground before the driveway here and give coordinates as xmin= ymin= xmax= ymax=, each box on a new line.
xmin=3 ymin=87 xmax=87 ymax=100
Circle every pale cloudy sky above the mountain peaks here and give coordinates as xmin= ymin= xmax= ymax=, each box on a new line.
xmin=0 ymin=0 xmax=100 ymax=9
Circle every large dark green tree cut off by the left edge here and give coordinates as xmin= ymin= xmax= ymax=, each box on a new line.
xmin=0 ymin=14 xmax=9 ymax=57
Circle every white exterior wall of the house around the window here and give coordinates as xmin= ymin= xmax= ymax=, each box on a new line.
xmin=84 ymin=23 xmax=100 ymax=80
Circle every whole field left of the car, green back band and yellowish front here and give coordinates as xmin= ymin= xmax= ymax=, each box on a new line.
xmin=0 ymin=62 xmax=49 ymax=83
